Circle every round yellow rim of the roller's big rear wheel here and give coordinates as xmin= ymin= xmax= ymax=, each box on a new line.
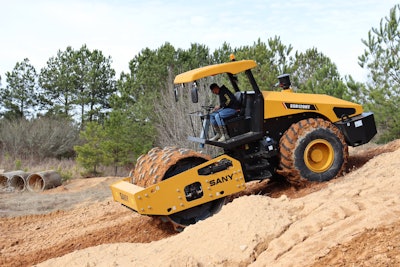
xmin=304 ymin=139 xmax=335 ymax=172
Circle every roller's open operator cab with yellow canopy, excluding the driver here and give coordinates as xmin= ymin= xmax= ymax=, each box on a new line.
xmin=174 ymin=55 xmax=264 ymax=149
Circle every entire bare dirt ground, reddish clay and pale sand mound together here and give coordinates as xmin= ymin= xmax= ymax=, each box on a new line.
xmin=0 ymin=141 xmax=400 ymax=267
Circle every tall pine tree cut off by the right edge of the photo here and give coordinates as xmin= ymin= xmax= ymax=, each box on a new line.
xmin=358 ymin=5 xmax=400 ymax=142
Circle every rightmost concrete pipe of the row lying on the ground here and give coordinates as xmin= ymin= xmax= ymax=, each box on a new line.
xmin=26 ymin=171 xmax=61 ymax=192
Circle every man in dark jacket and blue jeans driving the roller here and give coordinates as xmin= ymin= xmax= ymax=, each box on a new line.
xmin=210 ymin=83 xmax=240 ymax=142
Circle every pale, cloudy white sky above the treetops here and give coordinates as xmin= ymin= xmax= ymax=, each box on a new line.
xmin=0 ymin=0 xmax=398 ymax=84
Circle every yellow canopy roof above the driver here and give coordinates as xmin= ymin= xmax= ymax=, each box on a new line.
xmin=174 ymin=60 xmax=257 ymax=84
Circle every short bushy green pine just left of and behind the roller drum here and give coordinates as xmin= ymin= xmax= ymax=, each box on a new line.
xmin=75 ymin=110 xmax=154 ymax=175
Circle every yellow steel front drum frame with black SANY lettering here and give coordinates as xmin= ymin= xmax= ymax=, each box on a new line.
xmin=111 ymin=155 xmax=246 ymax=215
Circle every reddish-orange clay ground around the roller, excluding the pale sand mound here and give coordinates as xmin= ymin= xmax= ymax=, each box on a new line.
xmin=0 ymin=141 xmax=400 ymax=266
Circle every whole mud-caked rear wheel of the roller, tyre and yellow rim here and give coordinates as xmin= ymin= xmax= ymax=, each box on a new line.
xmin=280 ymin=118 xmax=348 ymax=185
